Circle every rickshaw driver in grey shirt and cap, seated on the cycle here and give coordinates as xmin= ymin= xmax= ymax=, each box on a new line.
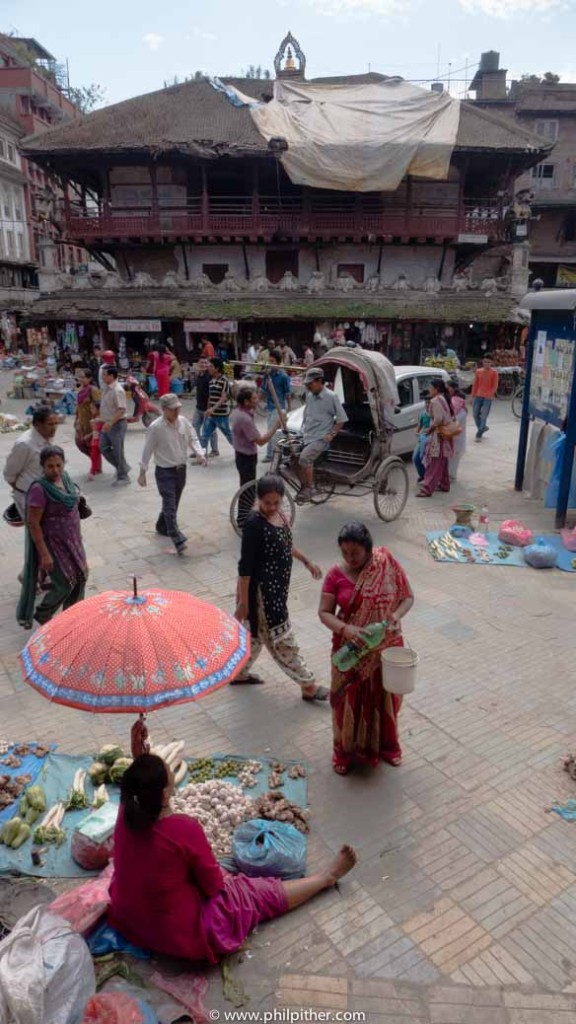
xmin=297 ymin=367 xmax=347 ymax=503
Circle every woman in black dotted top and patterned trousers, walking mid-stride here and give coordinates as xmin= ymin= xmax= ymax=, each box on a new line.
xmin=234 ymin=473 xmax=329 ymax=700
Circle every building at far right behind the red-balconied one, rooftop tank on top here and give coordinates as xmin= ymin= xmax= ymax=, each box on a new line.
xmin=470 ymin=51 xmax=576 ymax=288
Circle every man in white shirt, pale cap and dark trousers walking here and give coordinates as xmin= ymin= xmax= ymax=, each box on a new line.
xmin=138 ymin=394 xmax=206 ymax=555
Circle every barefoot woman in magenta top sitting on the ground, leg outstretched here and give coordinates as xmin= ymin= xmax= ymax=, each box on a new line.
xmin=109 ymin=754 xmax=356 ymax=964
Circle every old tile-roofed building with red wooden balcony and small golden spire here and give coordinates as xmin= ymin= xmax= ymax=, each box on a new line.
xmin=25 ymin=37 xmax=550 ymax=362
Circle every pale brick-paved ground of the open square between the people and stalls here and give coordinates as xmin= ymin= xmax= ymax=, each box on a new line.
xmin=0 ymin=380 xmax=576 ymax=1024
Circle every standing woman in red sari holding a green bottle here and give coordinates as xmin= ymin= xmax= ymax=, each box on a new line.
xmin=319 ymin=522 xmax=414 ymax=775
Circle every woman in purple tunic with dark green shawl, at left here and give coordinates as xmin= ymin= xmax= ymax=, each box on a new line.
xmin=16 ymin=444 xmax=88 ymax=630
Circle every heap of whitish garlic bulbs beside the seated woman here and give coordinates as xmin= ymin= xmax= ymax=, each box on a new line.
xmin=172 ymin=779 xmax=256 ymax=857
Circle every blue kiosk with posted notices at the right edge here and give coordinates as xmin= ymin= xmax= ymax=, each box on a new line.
xmin=515 ymin=288 xmax=576 ymax=529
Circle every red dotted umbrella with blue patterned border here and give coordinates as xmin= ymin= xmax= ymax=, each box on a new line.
xmin=19 ymin=580 xmax=250 ymax=753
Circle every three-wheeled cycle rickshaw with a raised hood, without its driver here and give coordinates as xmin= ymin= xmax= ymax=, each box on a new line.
xmin=230 ymin=347 xmax=409 ymax=536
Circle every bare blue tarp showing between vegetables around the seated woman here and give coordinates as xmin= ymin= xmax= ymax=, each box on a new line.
xmin=0 ymin=753 xmax=307 ymax=879
